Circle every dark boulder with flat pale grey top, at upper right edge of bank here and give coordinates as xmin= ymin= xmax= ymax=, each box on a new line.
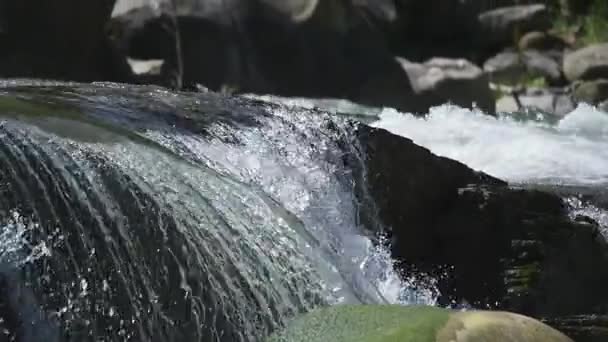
xmin=479 ymin=4 xmax=551 ymax=47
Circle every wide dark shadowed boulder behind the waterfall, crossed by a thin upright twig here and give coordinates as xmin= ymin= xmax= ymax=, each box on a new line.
xmin=108 ymin=1 xmax=428 ymax=112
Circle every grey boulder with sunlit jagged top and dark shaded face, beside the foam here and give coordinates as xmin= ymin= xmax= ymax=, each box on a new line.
xmin=397 ymin=58 xmax=495 ymax=113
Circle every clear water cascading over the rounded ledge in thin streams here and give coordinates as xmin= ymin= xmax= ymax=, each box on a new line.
xmin=0 ymin=81 xmax=435 ymax=341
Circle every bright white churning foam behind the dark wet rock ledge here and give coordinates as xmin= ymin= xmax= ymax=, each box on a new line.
xmin=373 ymin=105 xmax=608 ymax=185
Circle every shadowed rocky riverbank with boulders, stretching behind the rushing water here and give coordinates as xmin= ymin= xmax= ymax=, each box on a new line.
xmin=0 ymin=0 xmax=608 ymax=114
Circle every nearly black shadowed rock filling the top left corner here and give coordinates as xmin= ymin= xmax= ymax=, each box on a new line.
xmin=0 ymin=0 xmax=130 ymax=81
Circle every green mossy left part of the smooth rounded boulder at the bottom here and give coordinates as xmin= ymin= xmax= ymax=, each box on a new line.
xmin=267 ymin=305 xmax=450 ymax=342
